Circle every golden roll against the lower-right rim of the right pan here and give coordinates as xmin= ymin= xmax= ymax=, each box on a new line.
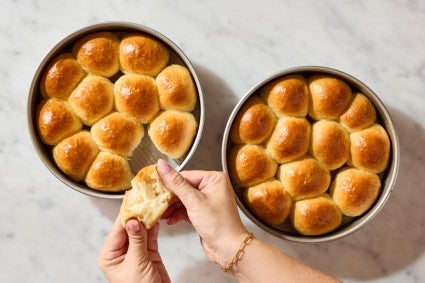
xmin=330 ymin=168 xmax=381 ymax=216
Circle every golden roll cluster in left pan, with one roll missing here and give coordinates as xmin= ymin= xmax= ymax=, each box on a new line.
xmin=37 ymin=32 xmax=198 ymax=192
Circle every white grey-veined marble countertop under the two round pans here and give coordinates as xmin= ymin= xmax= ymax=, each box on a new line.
xmin=0 ymin=0 xmax=425 ymax=283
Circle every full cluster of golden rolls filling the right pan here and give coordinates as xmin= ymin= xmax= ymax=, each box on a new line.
xmin=227 ymin=74 xmax=391 ymax=236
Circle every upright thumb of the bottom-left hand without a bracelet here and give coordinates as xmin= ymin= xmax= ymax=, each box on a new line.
xmin=126 ymin=219 xmax=148 ymax=261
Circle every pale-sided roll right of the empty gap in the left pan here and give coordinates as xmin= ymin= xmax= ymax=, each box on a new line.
xmin=148 ymin=110 xmax=198 ymax=159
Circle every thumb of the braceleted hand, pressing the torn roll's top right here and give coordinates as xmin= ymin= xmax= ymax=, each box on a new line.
xmin=157 ymin=159 xmax=199 ymax=207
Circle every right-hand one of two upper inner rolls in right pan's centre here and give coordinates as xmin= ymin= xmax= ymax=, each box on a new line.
xmin=310 ymin=120 xmax=350 ymax=170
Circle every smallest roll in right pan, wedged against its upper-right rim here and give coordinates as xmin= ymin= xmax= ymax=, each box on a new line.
xmin=340 ymin=93 xmax=376 ymax=132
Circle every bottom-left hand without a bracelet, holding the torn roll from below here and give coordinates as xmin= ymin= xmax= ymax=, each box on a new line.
xmin=98 ymin=215 xmax=170 ymax=282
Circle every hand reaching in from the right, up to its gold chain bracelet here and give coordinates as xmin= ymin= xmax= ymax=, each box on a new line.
xmin=157 ymin=160 xmax=248 ymax=267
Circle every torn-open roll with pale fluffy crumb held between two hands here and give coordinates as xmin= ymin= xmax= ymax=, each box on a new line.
xmin=121 ymin=164 xmax=174 ymax=230
